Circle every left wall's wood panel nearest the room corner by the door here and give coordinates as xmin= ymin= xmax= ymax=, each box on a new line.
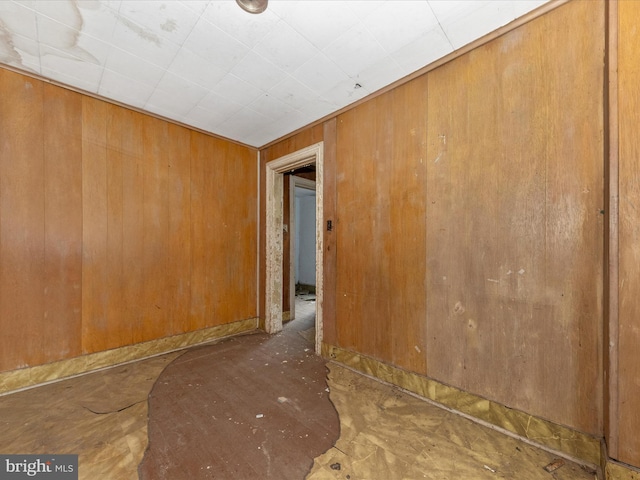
xmin=191 ymin=133 xmax=258 ymax=325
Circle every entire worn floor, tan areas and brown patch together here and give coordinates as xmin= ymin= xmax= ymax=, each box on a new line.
xmin=0 ymin=299 xmax=595 ymax=480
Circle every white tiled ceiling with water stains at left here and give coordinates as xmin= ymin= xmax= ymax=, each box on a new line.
xmin=0 ymin=0 xmax=546 ymax=147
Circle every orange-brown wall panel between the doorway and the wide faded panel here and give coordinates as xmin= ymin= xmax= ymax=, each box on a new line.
xmin=335 ymin=77 xmax=427 ymax=373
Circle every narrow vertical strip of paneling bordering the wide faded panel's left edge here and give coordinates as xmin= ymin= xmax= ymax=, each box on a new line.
xmin=390 ymin=77 xmax=429 ymax=374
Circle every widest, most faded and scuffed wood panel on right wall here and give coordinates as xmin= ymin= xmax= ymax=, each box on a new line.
xmin=426 ymin=2 xmax=604 ymax=435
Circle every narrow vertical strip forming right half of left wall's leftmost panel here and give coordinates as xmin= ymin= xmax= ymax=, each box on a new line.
xmin=42 ymin=84 xmax=82 ymax=361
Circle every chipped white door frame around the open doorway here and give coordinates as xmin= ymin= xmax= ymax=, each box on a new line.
xmin=265 ymin=142 xmax=324 ymax=354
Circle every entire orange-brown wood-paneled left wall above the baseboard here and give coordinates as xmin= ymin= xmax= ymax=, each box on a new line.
xmin=0 ymin=69 xmax=258 ymax=371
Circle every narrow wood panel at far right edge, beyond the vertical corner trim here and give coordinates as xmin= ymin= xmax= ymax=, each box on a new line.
xmin=611 ymin=0 xmax=640 ymax=467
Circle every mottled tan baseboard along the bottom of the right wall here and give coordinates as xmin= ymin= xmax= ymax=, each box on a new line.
xmin=322 ymin=343 xmax=604 ymax=470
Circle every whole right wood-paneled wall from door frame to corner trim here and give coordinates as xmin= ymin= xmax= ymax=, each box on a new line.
xmin=276 ymin=1 xmax=604 ymax=436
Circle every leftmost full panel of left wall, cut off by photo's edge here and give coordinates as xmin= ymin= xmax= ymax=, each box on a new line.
xmin=0 ymin=70 xmax=82 ymax=371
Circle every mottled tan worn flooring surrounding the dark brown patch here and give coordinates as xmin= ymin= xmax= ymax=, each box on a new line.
xmin=0 ymin=296 xmax=595 ymax=480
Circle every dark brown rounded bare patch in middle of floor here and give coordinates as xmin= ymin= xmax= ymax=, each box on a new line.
xmin=138 ymin=322 xmax=339 ymax=480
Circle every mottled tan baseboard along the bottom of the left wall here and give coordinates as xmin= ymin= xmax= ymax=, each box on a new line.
xmin=0 ymin=318 xmax=258 ymax=395
